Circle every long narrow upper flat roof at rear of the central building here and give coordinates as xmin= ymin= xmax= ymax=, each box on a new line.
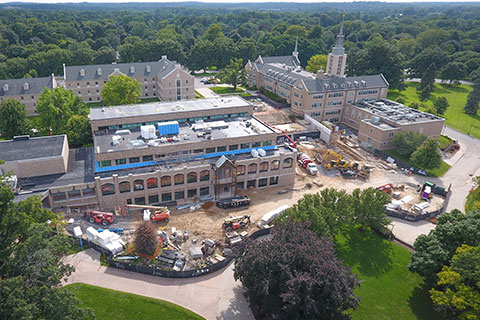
xmin=90 ymin=96 xmax=251 ymax=121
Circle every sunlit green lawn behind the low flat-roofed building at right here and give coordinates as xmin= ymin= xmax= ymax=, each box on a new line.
xmin=387 ymin=82 xmax=480 ymax=139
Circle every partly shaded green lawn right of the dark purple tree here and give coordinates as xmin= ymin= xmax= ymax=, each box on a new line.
xmin=335 ymin=230 xmax=438 ymax=320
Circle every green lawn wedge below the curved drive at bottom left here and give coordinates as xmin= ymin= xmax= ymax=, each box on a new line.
xmin=65 ymin=283 xmax=204 ymax=320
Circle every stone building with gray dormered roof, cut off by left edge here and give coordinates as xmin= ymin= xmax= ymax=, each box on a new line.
xmin=0 ymin=74 xmax=57 ymax=115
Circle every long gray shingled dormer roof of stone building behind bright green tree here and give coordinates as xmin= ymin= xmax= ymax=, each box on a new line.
xmin=65 ymin=58 xmax=185 ymax=81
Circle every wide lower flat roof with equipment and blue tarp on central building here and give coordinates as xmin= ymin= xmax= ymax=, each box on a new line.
xmin=94 ymin=117 xmax=275 ymax=154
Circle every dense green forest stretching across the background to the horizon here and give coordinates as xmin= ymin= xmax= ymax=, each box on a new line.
xmin=0 ymin=4 xmax=480 ymax=87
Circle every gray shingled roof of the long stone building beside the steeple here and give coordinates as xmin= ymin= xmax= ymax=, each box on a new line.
xmin=256 ymin=58 xmax=388 ymax=92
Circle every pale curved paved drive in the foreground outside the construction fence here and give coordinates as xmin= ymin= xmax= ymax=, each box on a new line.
xmin=64 ymin=249 xmax=254 ymax=320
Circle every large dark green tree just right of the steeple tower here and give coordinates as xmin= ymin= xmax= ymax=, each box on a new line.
xmin=354 ymin=36 xmax=405 ymax=89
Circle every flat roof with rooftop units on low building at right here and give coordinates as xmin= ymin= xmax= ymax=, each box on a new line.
xmin=353 ymin=99 xmax=445 ymax=125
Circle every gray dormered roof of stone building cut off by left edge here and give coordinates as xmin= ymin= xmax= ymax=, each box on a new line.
xmin=0 ymin=76 xmax=52 ymax=97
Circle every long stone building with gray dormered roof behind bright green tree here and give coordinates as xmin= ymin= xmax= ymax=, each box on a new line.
xmin=62 ymin=56 xmax=195 ymax=103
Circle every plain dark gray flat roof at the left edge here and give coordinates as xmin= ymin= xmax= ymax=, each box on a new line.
xmin=0 ymin=134 xmax=66 ymax=162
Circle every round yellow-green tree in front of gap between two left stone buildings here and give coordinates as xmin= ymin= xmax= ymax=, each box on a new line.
xmin=37 ymin=87 xmax=87 ymax=134
